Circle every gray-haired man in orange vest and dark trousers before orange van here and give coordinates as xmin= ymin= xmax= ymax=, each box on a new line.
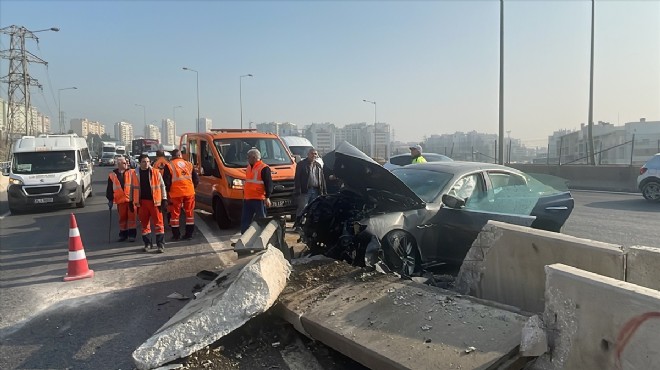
xmin=241 ymin=148 xmax=273 ymax=234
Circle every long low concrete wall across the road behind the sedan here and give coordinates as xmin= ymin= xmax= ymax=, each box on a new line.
xmin=509 ymin=163 xmax=639 ymax=192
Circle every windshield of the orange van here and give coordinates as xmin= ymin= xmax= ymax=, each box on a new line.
xmin=213 ymin=138 xmax=293 ymax=168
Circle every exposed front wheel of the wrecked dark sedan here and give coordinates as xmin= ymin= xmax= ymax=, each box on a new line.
xmin=383 ymin=230 xmax=422 ymax=276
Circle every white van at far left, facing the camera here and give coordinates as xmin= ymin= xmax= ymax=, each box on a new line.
xmin=3 ymin=134 xmax=93 ymax=214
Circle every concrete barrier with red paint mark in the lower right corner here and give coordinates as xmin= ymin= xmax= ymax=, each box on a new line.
xmin=532 ymin=264 xmax=660 ymax=370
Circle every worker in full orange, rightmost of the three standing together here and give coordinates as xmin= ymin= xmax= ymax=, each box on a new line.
xmin=163 ymin=149 xmax=199 ymax=240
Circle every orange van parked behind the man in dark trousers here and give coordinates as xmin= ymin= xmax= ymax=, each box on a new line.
xmin=180 ymin=129 xmax=296 ymax=229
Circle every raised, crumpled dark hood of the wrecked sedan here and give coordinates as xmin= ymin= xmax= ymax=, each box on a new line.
xmin=336 ymin=141 xmax=425 ymax=208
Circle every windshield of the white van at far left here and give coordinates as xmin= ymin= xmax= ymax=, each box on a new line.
xmin=12 ymin=150 xmax=76 ymax=175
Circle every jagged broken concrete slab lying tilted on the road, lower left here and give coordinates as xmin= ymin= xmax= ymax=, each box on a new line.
xmin=133 ymin=245 xmax=291 ymax=369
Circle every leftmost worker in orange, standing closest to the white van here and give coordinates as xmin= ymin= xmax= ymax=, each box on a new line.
xmin=105 ymin=157 xmax=137 ymax=242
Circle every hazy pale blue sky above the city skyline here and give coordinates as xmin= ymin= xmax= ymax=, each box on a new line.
xmin=0 ymin=0 xmax=660 ymax=146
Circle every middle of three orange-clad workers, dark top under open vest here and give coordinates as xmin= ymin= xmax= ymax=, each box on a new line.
xmin=130 ymin=154 xmax=167 ymax=253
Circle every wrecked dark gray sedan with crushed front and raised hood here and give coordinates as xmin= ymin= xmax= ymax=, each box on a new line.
xmin=300 ymin=142 xmax=574 ymax=276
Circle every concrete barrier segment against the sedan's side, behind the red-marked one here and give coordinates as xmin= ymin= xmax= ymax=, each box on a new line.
xmin=456 ymin=221 xmax=625 ymax=312
